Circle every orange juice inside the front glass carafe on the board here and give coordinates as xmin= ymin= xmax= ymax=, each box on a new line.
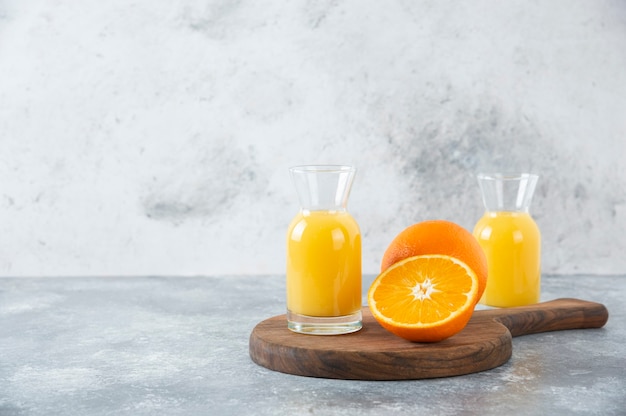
xmin=287 ymin=210 xmax=362 ymax=317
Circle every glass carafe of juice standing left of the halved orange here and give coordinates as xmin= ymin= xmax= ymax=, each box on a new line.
xmin=287 ymin=165 xmax=362 ymax=335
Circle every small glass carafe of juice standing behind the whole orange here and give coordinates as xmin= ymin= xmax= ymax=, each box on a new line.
xmin=473 ymin=173 xmax=541 ymax=307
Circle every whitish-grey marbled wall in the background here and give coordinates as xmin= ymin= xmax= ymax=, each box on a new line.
xmin=0 ymin=0 xmax=626 ymax=276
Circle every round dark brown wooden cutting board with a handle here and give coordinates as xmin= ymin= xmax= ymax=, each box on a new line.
xmin=249 ymin=299 xmax=609 ymax=380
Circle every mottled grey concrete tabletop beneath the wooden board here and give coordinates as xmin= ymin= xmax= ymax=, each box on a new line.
xmin=0 ymin=276 xmax=626 ymax=416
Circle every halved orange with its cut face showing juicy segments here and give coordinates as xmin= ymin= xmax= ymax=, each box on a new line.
xmin=367 ymin=254 xmax=479 ymax=342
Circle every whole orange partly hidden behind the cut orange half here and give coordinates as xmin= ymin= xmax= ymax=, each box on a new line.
xmin=380 ymin=220 xmax=487 ymax=299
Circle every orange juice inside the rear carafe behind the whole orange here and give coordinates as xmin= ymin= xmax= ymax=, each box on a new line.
xmin=474 ymin=211 xmax=541 ymax=307
